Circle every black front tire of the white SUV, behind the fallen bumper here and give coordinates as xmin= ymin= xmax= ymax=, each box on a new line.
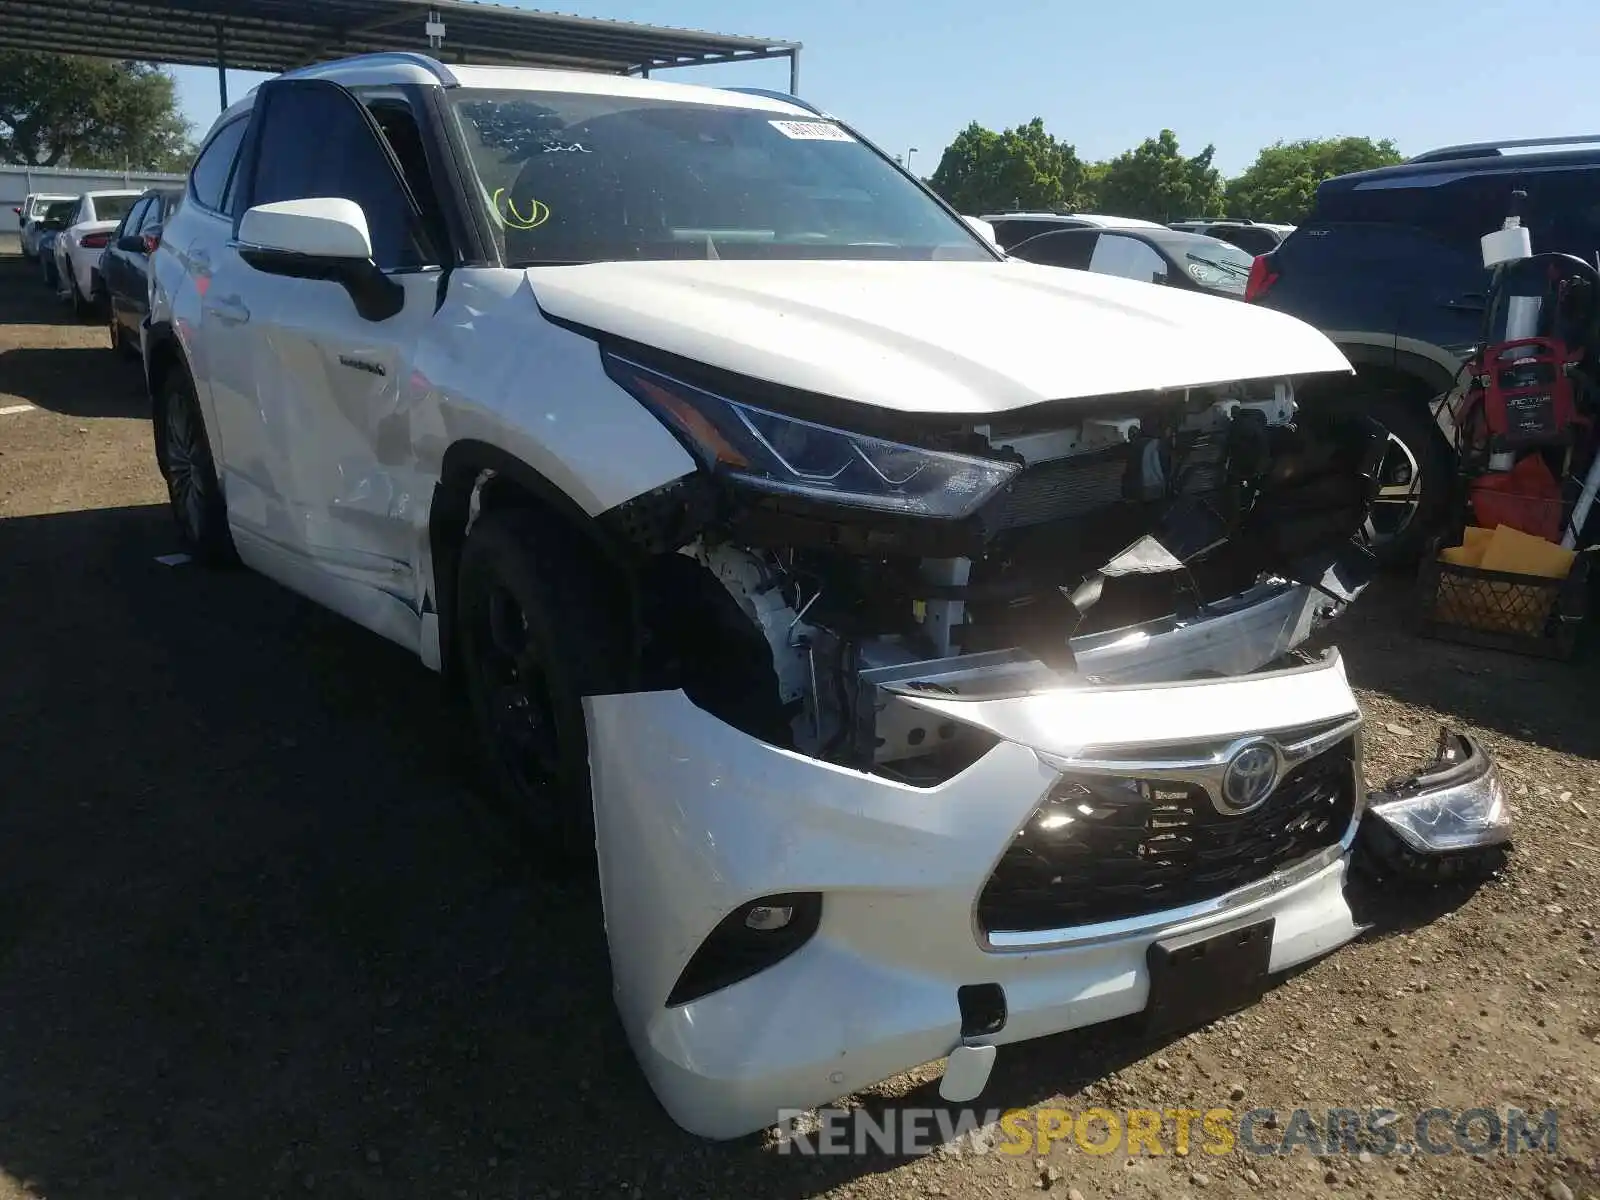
xmin=454 ymin=509 xmax=629 ymax=867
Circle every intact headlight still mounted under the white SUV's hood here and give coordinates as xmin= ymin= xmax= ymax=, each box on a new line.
xmin=603 ymin=354 xmax=1021 ymax=518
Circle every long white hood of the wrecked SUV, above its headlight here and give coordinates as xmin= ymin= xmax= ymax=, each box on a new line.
xmin=528 ymin=259 xmax=1350 ymax=416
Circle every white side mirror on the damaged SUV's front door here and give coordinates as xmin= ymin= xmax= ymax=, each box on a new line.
xmin=238 ymin=197 xmax=405 ymax=322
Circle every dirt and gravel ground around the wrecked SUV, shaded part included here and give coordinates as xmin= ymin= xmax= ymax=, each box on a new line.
xmin=0 ymin=246 xmax=1600 ymax=1200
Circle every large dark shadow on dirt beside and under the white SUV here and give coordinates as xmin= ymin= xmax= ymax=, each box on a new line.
xmin=0 ymin=506 xmax=1510 ymax=1200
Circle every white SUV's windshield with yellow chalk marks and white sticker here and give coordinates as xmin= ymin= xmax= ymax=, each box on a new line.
xmin=451 ymin=90 xmax=994 ymax=266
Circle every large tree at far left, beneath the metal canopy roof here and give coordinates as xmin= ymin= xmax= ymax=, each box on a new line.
xmin=0 ymin=50 xmax=192 ymax=170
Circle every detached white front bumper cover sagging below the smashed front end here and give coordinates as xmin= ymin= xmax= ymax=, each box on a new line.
xmin=586 ymin=611 xmax=1490 ymax=1138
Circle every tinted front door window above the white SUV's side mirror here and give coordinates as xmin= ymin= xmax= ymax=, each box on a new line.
xmin=250 ymin=83 xmax=429 ymax=270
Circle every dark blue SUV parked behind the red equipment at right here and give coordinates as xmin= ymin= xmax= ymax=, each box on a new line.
xmin=1245 ymin=136 xmax=1600 ymax=563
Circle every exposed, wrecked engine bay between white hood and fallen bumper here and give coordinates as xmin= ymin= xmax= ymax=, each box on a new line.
xmin=624 ymin=379 xmax=1382 ymax=784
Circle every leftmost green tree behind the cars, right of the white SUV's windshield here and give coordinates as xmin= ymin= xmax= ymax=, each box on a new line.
xmin=928 ymin=117 xmax=1083 ymax=214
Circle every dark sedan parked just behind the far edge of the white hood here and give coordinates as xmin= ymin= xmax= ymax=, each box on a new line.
xmin=1008 ymin=226 xmax=1253 ymax=299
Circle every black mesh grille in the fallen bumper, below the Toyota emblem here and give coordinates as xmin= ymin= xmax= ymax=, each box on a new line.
xmin=978 ymin=738 xmax=1355 ymax=933
